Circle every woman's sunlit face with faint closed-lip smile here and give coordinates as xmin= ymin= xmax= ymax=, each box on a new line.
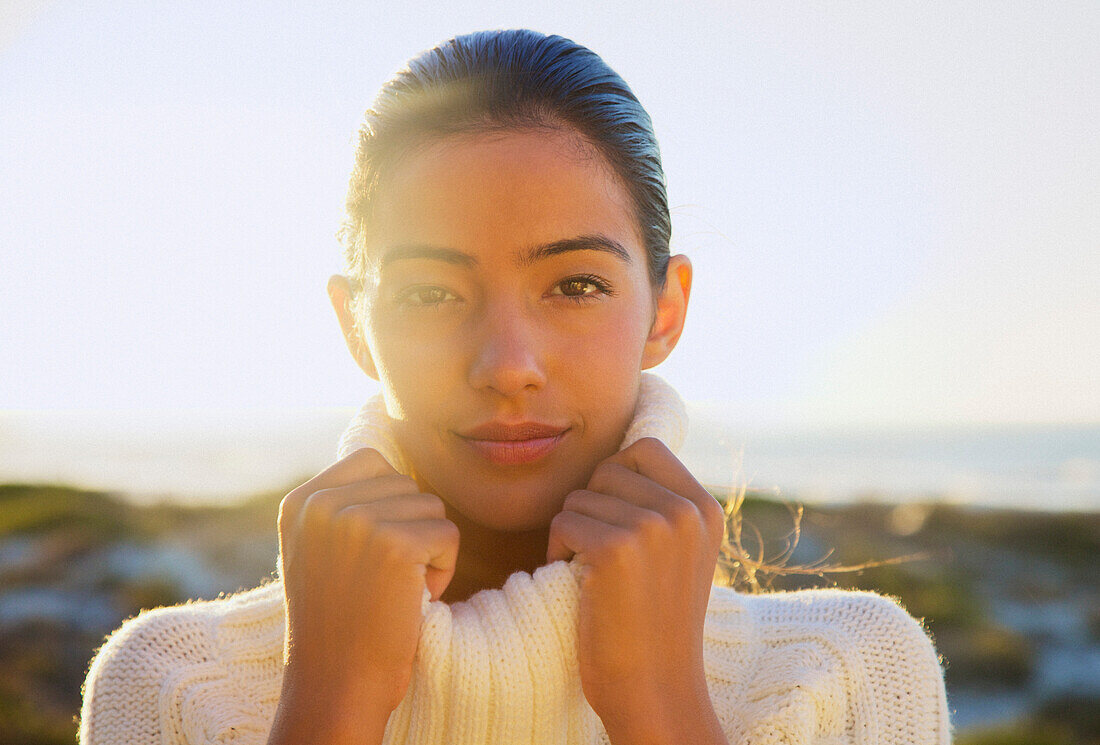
xmin=334 ymin=129 xmax=690 ymax=530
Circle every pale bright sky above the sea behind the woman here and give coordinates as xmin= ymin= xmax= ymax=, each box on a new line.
xmin=0 ymin=0 xmax=1100 ymax=425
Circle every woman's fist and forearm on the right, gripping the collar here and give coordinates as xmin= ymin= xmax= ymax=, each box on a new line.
xmin=547 ymin=438 xmax=725 ymax=743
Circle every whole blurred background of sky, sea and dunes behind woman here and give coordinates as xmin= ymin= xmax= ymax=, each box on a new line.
xmin=0 ymin=0 xmax=1100 ymax=744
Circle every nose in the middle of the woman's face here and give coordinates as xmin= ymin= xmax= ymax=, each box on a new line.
xmin=470 ymin=307 xmax=547 ymax=397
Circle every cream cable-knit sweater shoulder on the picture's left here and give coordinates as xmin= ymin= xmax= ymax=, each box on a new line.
xmin=80 ymin=582 xmax=285 ymax=745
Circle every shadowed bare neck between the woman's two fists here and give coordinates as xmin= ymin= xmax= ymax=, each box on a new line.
xmin=442 ymin=505 xmax=550 ymax=603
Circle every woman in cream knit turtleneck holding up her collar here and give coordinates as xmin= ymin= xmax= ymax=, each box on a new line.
xmin=81 ymin=31 xmax=949 ymax=745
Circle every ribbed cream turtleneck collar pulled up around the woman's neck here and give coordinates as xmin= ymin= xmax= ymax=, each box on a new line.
xmin=321 ymin=373 xmax=688 ymax=743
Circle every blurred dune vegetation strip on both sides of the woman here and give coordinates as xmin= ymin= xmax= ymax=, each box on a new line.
xmin=0 ymin=485 xmax=1100 ymax=745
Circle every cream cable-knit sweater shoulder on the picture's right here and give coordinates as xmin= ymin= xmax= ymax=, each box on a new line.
xmin=705 ymin=588 xmax=950 ymax=744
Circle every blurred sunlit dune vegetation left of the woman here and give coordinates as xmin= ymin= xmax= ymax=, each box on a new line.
xmin=0 ymin=485 xmax=279 ymax=745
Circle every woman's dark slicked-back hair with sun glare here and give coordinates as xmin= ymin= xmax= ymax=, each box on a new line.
xmin=340 ymin=30 xmax=672 ymax=287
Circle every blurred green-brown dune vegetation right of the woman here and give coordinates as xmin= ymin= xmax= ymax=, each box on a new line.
xmin=741 ymin=495 xmax=1100 ymax=745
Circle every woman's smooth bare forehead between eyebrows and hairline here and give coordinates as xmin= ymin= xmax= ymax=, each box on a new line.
xmin=367 ymin=128 xmax=645 ymax=258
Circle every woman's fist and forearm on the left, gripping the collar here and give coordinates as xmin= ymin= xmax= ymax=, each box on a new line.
xmin=268 ymin=449 xmax=459 ymax=743
